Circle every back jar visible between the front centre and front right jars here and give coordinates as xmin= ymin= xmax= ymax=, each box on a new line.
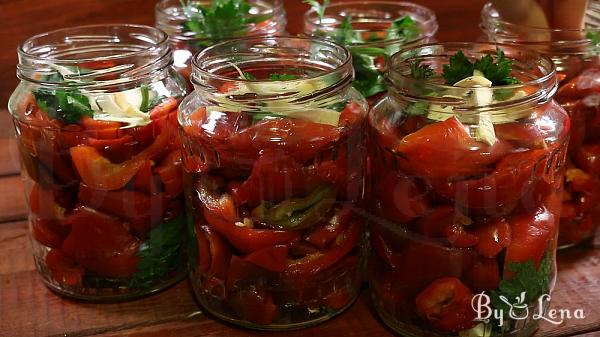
xmin=304 ymin=1 xmax=438 ymax=105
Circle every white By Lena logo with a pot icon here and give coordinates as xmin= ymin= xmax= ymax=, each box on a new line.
xmin=471 ymin=292 xmax=585 ymax=327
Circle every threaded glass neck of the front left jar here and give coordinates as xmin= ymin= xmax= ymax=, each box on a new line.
xmin=17 ymin=25 xmax=173 ymax=90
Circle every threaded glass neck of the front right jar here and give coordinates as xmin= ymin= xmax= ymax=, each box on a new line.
xmin=387 ymin=43 xmax=557 ymax=120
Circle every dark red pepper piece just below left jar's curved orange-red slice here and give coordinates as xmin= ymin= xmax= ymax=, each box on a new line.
xmin=79 ymin=184 xmax=166 ymax=236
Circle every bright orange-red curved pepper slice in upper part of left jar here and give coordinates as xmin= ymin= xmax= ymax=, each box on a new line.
xmin=70 ymin=128 xmax=170 ymax=190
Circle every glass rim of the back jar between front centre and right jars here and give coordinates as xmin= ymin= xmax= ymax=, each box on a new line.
xmin=304 ymin=0 xmax=439 ymax=47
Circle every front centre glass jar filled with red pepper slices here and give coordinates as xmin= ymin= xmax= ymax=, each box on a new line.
xmin=179 ymin=37 xmax=367 ymax=330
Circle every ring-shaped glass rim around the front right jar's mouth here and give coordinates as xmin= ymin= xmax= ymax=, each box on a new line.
xmin=387 ymin=42 xmax=558 ymax=110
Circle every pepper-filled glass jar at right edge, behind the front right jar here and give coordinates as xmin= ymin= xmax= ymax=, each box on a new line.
xmin=481 ymin=0 xmax=600 ymax=248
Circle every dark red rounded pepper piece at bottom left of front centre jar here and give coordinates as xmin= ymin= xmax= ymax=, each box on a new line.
xmin=229 ymin=289 xmax=279 ymax=325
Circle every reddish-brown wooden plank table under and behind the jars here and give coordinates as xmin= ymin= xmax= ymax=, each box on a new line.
xmin=0 ymin=0 xmax=600 ymax=337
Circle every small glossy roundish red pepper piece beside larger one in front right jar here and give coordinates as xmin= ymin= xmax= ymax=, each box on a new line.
xmin=472 ymin=218 xmax=511 ymax=258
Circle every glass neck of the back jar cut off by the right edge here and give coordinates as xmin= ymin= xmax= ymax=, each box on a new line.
xmin=481 ymin=0 xmax=600 ymax=58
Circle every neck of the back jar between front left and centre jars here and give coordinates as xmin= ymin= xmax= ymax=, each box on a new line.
xmin=155 ymin=0 xmax=286 ymax=49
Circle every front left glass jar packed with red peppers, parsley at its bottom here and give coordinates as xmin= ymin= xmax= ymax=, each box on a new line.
xmin=9 ymin=25 xmax=186 ymax=301
